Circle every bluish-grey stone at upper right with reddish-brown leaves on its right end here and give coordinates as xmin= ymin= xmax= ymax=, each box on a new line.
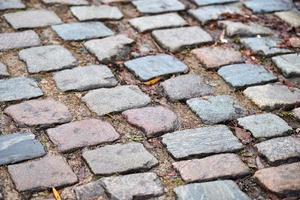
xmin=240 ymin=37 xmax=291 ymax=56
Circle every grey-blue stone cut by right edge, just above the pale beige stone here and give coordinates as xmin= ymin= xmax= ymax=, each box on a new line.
xmin=272 ymin=54 xmax=300 ymax=77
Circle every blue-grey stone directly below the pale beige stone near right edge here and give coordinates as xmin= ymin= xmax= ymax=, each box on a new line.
xmin=238 ymin=113 xmax=293 ymax=138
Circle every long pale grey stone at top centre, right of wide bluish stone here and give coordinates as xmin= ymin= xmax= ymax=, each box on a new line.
xmin=129 ymin=13 xmax=187 ymax=32
